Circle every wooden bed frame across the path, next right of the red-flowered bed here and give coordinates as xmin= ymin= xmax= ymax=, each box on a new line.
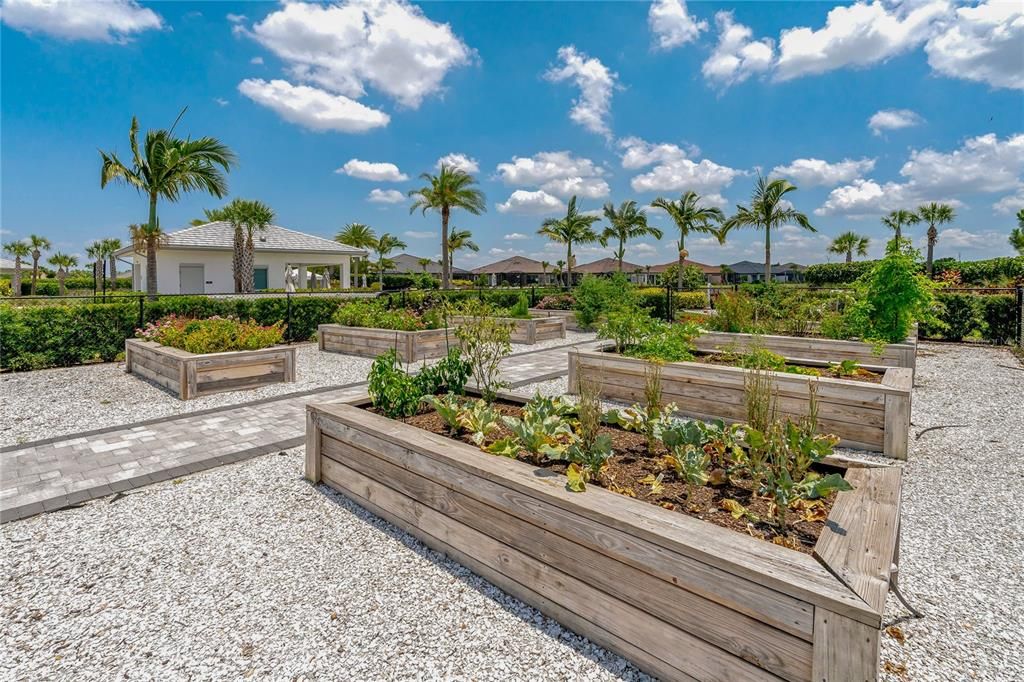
xmin=316 ymin=325 xmax=458 ymax=363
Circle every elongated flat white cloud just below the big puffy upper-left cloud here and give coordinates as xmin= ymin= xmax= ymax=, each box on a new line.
xmin=239 ymin=78 xmax=391 ymax=132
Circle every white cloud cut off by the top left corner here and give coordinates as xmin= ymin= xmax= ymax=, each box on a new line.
xmin=0 ymin=0 xmax=164 ymax=43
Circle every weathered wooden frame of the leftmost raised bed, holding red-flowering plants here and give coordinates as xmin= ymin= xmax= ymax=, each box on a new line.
xmin=125 ymin=339 xmax=296 ymax=400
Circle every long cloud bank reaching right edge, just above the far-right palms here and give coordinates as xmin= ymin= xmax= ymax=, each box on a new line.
xmin=815 ymin=133 xmax=1024 ymax=216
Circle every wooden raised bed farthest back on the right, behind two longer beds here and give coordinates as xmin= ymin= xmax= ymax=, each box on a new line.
xmin=693 ymin=332 xmax=918 ymax=370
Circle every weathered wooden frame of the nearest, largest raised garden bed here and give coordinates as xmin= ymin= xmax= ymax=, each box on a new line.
xmin=305 ymin=398 xmax=900 ymax=682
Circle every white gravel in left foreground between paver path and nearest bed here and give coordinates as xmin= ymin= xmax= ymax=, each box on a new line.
xmin=0 ymin=450 xmax=646 ymax=682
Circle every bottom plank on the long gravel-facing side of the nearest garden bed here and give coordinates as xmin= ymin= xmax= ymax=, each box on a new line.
xmin=323 ymin=460 xmax=777 ymax=681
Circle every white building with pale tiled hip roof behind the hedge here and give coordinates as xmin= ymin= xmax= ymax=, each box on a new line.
xmin=117 ymin=221 xmax=367 ymax=294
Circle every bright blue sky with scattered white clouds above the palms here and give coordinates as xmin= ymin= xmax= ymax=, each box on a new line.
xmin=0 ymin=0 xmax=1024 ymax=267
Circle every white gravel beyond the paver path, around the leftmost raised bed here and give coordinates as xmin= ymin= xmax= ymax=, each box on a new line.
xmin=0 ymin=332 xmax=594 ymax=445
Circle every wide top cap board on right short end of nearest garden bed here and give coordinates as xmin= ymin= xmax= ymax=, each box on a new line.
xmin=814 ymin=467 xmax=903 ymax=615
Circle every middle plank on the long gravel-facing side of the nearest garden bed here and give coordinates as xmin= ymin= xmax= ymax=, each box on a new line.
xmin=321 ymin=435 xmax=811 ymax=680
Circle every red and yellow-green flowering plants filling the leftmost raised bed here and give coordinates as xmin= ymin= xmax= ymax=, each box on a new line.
xmin=136 ymin=315 xmax=285 ymax=353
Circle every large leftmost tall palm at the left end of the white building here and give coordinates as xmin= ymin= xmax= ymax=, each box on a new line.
xmin=99 ymin=110 xmax=234 ymax=298
